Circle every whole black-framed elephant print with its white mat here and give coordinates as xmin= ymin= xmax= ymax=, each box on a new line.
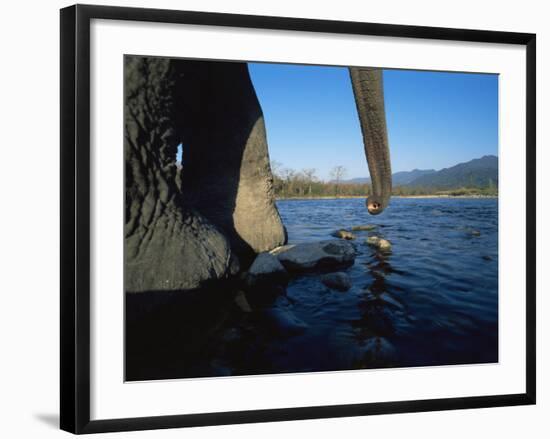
xmin=61 ymin=5 xmax=536 ymax=433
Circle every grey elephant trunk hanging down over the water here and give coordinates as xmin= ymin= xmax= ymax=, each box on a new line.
xmin=349 ymin=67 xmax=392 ymax=215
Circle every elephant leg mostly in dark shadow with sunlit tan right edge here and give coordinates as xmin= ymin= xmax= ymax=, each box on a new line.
xmin=179 ymin=61 xmax=286 ymax=261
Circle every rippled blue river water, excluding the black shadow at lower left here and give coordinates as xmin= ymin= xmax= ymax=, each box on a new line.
xmin=266 ymin=198 xmax=498 ymax=371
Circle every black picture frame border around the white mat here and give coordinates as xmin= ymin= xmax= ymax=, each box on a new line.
xmin=60 ymin=5 xmax=536 ymax=434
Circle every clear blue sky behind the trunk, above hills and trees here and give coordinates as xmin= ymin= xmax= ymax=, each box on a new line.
xmin=249 ymin=63 xmax=498 ymax=179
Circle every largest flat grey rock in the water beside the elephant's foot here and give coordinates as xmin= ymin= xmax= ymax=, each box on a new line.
xmin=277 ymin=239 xmax=355 ymax=272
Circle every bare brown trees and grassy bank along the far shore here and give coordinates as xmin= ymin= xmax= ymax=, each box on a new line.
xmin=271 ymin=161 xmax=498 ymax=198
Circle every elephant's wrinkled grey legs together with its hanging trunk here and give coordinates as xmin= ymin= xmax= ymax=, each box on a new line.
xmin=124 ymin=55 xmax=391 ymax=293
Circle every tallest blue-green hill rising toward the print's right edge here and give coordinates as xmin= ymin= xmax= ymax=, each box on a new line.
xmin=405 ymin=155 xmax=498 ymax=189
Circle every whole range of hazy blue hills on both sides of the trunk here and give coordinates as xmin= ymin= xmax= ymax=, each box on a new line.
xmin=342 ymin=155 xmax=498 ymax=189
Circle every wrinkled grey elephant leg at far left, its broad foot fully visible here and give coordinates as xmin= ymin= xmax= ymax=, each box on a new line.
xmin=124 ymin=56 xmax=234 ymax=293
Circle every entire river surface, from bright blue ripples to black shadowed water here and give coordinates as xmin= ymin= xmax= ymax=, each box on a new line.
xmin=127 ymin=199 xmax=498 ymax=379
